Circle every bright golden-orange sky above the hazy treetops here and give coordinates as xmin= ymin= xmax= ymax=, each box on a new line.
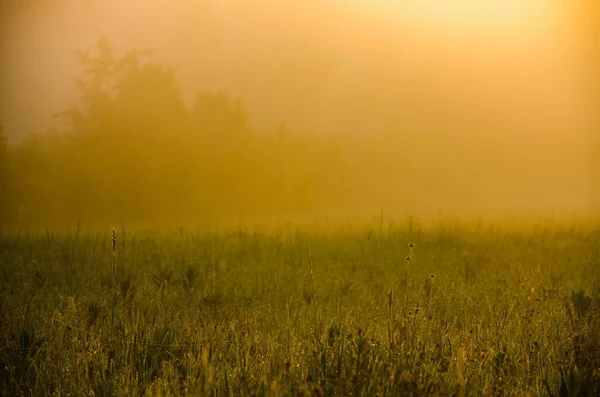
xmin=0 ymin=0 xmax=584 ymax=140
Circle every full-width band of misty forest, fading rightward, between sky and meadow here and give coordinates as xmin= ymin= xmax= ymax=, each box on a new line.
xmin=0 ymin=37 xmax=590 ymax=229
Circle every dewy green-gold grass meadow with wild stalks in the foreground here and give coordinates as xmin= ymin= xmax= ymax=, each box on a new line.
xmin=0 ymin=219 xmax=600 ymax=396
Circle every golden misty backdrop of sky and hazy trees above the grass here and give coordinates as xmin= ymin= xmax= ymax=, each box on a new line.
xmin=0 ymin=0 xmax=600 ymax=227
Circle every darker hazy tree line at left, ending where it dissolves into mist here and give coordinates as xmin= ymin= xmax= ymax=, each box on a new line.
xmin=0 ymin=39 xmax=398 ymax=227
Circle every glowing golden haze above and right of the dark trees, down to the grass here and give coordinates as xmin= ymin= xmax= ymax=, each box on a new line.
xmin=0 ymin=0 xmax=600 ymax=226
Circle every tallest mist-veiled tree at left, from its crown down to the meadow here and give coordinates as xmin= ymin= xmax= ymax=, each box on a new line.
xmin=47 ymin=38 xmax=195 ymax=221
